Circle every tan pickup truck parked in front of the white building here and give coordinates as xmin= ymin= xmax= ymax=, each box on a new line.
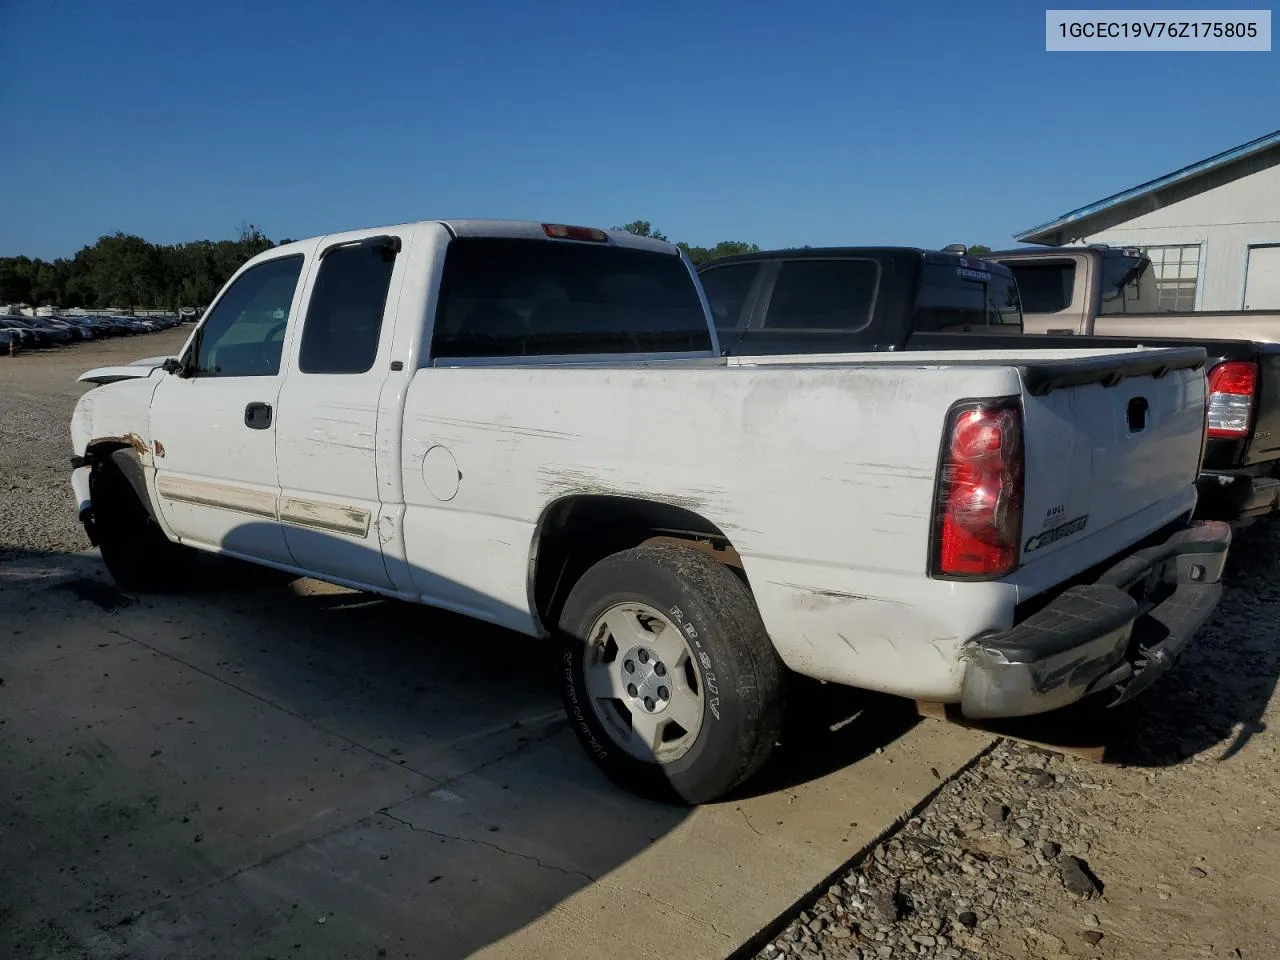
xmin=983 ymin=247 xmax=1280 ymax=343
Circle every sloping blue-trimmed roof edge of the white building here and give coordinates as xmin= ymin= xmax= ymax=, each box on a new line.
xmin=1014 ymin=131 xmax=1280 ymax=244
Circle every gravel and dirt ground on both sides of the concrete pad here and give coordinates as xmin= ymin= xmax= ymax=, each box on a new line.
xmin=0 ymin=328 xmax=1280 ymax=960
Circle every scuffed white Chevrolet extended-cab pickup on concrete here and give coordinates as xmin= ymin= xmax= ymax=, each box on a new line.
xmin=72 ymin=220 xmax=1230 ymax=803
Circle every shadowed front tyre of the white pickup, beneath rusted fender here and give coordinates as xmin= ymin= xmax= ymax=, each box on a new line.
xmin=88 ymin=458 xmax=193 ymax=593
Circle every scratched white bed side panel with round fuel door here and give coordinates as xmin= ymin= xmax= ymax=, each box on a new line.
xmin=402 ymin=366 xmax=1019 ymax=687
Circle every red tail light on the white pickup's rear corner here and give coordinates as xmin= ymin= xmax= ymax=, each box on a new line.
xmin=931 ymin=398 xmax=1024 ymax=580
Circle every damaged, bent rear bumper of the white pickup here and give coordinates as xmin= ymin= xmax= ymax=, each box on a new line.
xmin=960 ymin=521 xmax=1231 ymax=719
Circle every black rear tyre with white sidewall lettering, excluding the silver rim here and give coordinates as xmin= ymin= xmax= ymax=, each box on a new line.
xmin=559 ymin=545 xmax=786 ymax=804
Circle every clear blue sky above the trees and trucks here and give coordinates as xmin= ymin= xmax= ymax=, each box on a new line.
xmin=0 ymin=0 xmax=1280 ymax=257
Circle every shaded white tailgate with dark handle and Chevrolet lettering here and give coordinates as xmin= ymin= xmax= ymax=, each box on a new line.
xmin=1021 ymin=347 xmax=1206 ymax=573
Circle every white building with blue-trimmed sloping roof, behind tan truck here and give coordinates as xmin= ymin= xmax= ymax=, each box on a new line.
xmin=1018 ymin=131 xmax=1280 ymax=310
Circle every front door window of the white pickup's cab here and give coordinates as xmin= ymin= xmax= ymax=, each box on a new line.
xmin=191 ymin=255 xmax=303 ymax=376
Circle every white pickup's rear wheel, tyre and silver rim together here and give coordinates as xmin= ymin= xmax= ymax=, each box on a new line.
xmin=559 ymin=545 xmax=785 ymax=804
